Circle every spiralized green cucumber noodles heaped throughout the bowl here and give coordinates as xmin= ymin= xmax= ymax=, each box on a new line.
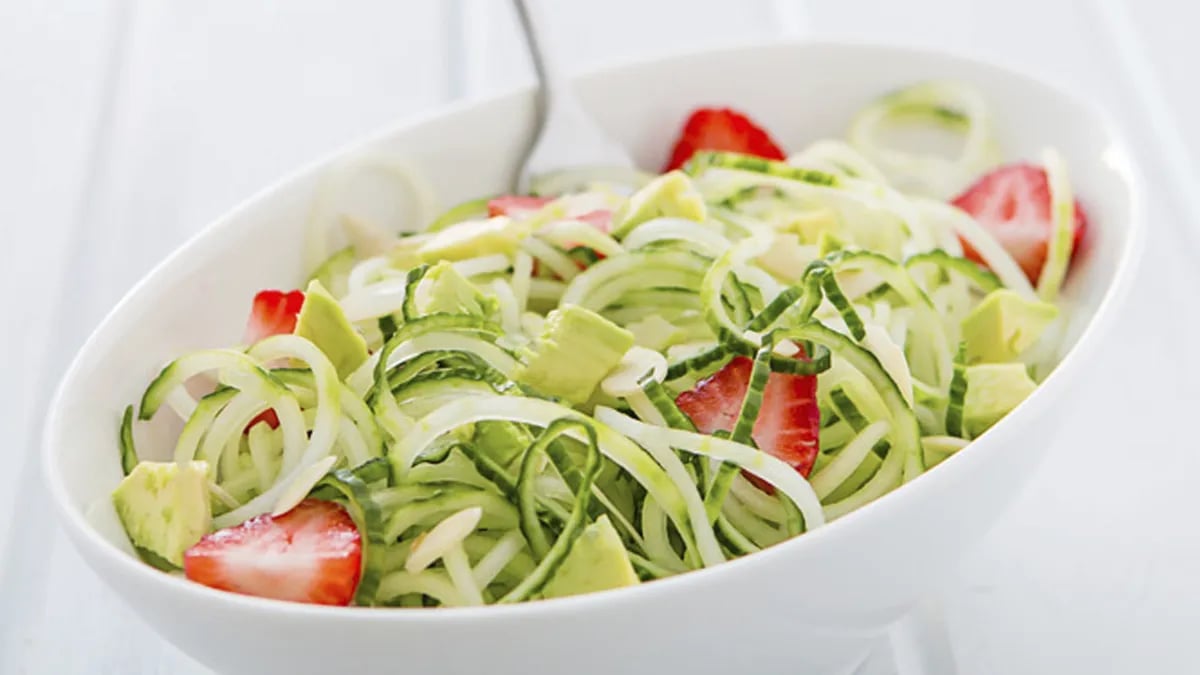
xmin=121 ymin=83 xmax=1073 ymax=607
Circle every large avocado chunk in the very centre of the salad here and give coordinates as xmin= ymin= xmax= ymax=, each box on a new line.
xmin=515 ymin=305 xmax=634 ymax=405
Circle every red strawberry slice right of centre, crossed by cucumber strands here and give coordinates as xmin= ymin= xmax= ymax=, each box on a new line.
xmin=676 ymin=357 xmax=821 ymax=491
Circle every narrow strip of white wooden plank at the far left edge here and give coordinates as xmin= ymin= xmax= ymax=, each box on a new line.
xmin=0 ymin=0 xmax=123 ymax=552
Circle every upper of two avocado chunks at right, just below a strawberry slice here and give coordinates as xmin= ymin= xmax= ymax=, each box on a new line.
xmin=962 ymin=288 xmax=1058 ymax=363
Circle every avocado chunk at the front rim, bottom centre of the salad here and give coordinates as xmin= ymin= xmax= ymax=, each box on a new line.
xmin=541 ymin=515 xmax=638 ymax=598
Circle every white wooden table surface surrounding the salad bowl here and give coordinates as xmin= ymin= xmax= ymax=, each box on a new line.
xmin=0 ymin=0 xmax=1200 ymax=675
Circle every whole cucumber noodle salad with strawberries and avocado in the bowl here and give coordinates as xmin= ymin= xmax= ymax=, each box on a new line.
xmin=112 ymin=82 xmax=1087 ymax=608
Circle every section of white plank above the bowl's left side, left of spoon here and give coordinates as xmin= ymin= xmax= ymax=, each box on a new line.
xmin=77 ymin=0 xmax=446 ymax=319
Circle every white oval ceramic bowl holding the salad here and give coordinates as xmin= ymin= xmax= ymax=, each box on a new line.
xmin=44 ymin=44 xmax=1144 ymax=675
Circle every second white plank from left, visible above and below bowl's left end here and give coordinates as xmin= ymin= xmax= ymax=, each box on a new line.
xmin=0 ymin=0 xmax=448 ymax=674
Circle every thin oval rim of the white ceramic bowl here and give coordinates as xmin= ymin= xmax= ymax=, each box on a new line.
xmin=40 ymin=38 xmax=1146 ymax=625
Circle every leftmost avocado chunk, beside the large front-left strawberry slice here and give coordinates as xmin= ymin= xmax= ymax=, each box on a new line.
xmin=113 ymin=461 xmax=212 ymax=567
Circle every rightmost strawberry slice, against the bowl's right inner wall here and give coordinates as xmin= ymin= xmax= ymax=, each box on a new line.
xmin=952 ymin=163 xmax=1087 ymax=283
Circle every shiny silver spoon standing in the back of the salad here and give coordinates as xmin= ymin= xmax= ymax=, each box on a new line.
xmin=512 ymin=0 xmax=634 ymax=195
